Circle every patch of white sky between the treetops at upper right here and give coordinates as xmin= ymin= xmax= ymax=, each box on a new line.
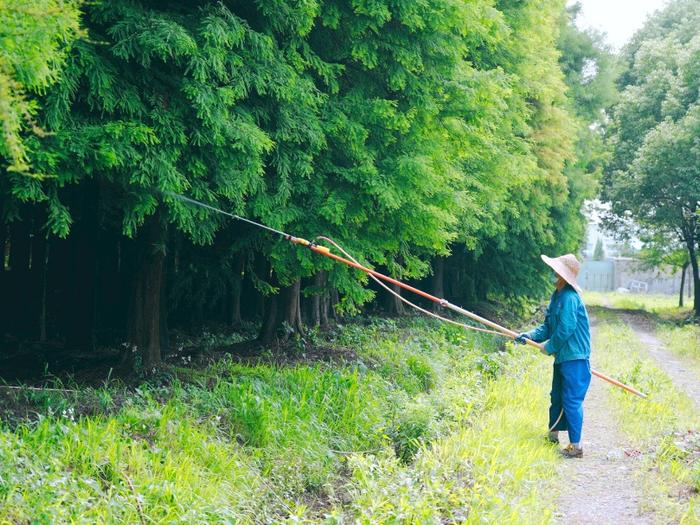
xmin=568 ymin=0 xmax=667 ymax=50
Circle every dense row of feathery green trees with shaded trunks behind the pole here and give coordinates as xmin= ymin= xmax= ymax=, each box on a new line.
xmin=0 ymin=0 xmax=610 ymax=363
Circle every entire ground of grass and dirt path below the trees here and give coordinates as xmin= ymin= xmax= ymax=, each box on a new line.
xmin=0 ymin=296 xmax=700 ymax=525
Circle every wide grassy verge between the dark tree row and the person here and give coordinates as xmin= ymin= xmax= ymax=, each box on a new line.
xmin=0 ymin=320 xmax=557 ymax=525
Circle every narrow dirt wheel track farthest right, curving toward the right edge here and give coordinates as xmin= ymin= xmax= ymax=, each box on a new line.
xmin=621 ymin=313 xmax=700 ymax=408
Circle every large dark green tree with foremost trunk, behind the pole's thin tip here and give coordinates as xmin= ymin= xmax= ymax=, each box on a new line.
xmin=19 ymin=1 xmax=319 ymax=367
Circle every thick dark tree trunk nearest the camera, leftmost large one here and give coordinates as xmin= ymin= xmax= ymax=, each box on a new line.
xmin=128 ymin=213 xmax=165 ymax=369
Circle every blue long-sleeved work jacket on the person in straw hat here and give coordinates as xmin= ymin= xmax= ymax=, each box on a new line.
xmin=527 ymin=284 xmax=591 ymax=363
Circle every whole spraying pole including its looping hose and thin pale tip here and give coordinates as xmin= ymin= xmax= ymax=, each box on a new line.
xmin=164 ymin=192 xmax=647 ymax=398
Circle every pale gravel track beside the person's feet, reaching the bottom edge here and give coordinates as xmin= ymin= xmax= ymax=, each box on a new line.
xmin=555 ymin=319 xmax=651 ymax=525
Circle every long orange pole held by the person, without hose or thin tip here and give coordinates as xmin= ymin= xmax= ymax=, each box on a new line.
xmin=308 ymin=245 xmax=647 ymax=398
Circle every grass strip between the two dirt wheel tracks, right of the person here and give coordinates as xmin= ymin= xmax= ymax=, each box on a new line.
xmin=593 ymin=311 xmax=700 ymax=524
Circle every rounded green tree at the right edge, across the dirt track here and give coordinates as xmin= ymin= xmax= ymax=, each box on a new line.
xmin=603 ymin=0 xmax=700 ymax=315
